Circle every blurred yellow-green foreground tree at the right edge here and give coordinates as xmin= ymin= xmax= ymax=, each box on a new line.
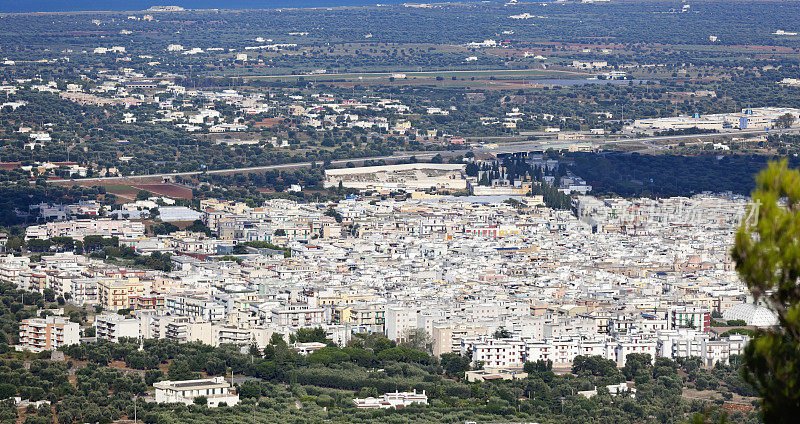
xmin=732 ymin=159 xmax=800 ymax=423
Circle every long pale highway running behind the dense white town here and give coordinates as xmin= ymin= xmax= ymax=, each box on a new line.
xmin=48 ymin=128 xmax=800 ymax=183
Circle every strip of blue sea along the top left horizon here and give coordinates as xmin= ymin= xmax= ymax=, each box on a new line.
xmin=0 ymin=0 xmax=409 ymax=12
